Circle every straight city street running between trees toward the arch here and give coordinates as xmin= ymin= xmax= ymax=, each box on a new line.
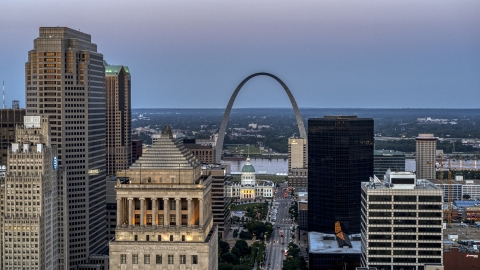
xmin=264 ymin=184 xmax=293 ymax=270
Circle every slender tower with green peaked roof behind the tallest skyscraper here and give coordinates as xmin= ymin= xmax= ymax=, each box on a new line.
xmin=103 ymin=61 xmax=132 ymax=176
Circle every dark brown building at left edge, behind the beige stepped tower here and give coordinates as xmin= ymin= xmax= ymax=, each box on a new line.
xmin=0 ymin=109 xmax=25 ymax=169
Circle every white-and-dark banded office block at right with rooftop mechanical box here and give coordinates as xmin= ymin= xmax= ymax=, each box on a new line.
xmin=362 ymin=172 xmax=443 ymax=270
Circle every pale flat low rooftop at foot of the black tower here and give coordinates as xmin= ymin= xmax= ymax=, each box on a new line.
xmin=308 ymin=232 xmax=362 ymax=254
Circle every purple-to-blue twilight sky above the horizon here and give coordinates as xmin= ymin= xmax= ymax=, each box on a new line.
xmin=0 ymin=0 xmax=480 ymax=108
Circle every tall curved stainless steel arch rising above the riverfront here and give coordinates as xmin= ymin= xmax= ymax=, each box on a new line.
xmin=215 ymin=72 xmax=307 ymax=163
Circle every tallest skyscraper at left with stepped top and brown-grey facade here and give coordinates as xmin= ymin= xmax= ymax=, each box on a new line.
xmin=25 ymin=27 xmax=107 ymax=269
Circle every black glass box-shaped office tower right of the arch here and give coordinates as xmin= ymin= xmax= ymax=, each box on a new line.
xmin=308 ymin=116 xmax=373 ymax=234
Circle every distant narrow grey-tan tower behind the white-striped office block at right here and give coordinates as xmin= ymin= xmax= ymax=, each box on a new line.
xmin=415 ymin=134 xmax=437 ymax=179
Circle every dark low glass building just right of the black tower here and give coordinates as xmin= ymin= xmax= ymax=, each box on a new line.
xmin=373 ymin=150 xmax=405 ymax=180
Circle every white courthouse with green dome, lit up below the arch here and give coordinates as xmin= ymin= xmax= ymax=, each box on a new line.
xmin=225 ymin=157 xmax=275 ymax=199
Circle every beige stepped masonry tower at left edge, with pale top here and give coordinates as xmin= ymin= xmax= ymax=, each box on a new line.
xmin=0 ymin=116 xmax=65 ymax=270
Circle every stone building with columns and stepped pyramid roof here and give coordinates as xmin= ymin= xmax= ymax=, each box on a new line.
xmin=109 ymin=127 xmax=218 ymax=270
